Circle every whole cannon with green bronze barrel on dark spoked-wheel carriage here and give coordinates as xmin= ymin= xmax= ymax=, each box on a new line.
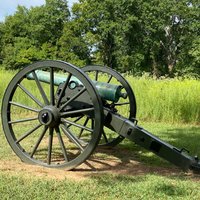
xmin=1 ymin=60 xmax=200 ymax=172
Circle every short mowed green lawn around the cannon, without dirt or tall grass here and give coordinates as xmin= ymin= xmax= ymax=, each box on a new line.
xmin=0 ymin=123 xmax=200 ymax=200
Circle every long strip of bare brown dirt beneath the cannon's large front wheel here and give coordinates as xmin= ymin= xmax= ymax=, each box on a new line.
xmin=0 ymin=159 xmax=180 ymax=181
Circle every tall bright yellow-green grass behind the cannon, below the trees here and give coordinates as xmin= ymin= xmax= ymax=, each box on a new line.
xmin=0 ymin=70 xmax=200 ymax=124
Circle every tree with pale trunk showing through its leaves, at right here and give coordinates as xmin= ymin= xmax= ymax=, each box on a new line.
xmin=141 ymin=0 xmax=199 ymax=76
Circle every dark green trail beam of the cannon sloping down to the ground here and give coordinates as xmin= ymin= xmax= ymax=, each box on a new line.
xmin=104 ymin=109 xmax=200 ymax=172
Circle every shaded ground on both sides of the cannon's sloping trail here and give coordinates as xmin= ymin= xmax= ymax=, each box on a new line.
xmin=74 ymin=127 xmax=200 ymax=176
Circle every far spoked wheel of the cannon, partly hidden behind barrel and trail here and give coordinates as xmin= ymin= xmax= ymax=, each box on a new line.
xmin=82 ymin=65 xmax=136 ymax=146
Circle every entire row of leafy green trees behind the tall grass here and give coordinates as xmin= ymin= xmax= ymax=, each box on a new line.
xmin=0 ymin=0 xmax=200 ymax=77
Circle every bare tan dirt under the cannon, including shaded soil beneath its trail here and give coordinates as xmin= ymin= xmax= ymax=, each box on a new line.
xmin=0 ymin=147 xmax=200 ymax=181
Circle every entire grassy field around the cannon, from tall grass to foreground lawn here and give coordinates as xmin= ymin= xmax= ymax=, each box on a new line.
xmin=0 ymin=71 xmax=200 ymax=200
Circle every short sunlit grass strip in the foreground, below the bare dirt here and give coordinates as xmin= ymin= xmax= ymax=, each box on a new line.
xmin=0 ymin=170 xmax=200 ymax=200
